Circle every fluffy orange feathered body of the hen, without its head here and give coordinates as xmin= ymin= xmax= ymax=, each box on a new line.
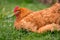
xmin=14 ymin=0 xmax=60 ymax=33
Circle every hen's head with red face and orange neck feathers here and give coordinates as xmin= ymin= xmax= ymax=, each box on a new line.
xmin=14 ymin=6 xmax=32 ymax=18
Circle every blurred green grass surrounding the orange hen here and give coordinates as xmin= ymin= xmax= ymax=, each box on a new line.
xmin=0 ymin=0 xmax=60 ymax=40
